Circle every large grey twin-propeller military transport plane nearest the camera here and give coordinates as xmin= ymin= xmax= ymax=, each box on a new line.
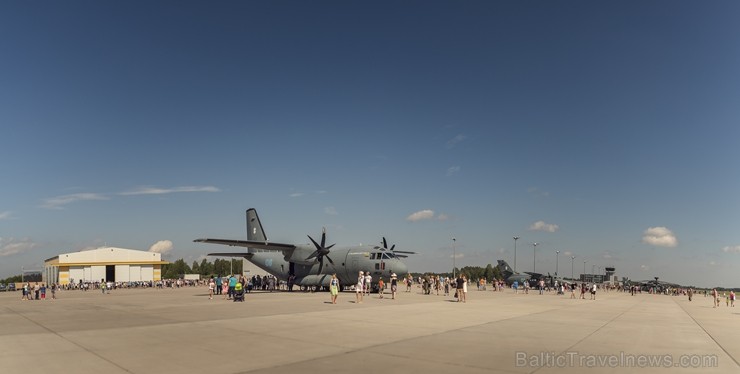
xmin=194 ymin=208 xmax=415 ymax=287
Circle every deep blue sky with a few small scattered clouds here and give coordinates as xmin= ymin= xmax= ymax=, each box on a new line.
xmin=0 ymin=1 xmax=740 ymax=286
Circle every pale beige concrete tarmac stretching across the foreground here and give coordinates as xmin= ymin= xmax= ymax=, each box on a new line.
xmin=0 ymin=287 xmax=740 ymax=374
